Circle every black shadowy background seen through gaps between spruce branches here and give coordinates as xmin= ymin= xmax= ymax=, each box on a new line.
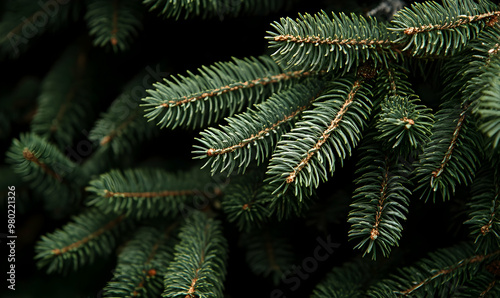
xmin=0 ymin=0 xmax=467 ymax=297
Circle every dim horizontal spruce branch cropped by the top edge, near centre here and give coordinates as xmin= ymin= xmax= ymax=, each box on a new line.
xmin=143 ymin=0 xmax=292 ymax=20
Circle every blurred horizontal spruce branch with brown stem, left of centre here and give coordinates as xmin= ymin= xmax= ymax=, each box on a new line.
xmin=86 ymin=169 xmax=220 ymax=218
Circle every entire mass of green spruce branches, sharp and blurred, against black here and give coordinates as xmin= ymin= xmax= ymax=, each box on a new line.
xmin=0 ymin=0 xmax=500 ymax=298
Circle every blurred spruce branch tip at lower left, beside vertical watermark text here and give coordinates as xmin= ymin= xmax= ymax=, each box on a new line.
xmin=35 ymin=209 xmax=130 ymax=273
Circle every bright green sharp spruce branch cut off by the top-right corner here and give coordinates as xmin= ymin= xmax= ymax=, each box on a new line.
xmin=389 ymin=0 xmax=500 ymax=56
